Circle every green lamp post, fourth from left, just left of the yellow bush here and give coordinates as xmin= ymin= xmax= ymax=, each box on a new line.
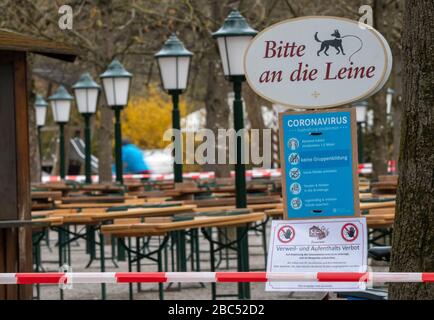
xmin=100 ymin=59 xmax=133 ymax=184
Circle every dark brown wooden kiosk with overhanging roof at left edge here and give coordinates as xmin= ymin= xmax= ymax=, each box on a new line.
xmin=0 ymin=29 xmax=76 ymax=300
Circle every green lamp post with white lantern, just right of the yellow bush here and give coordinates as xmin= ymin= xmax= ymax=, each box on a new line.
xmin=155 ymin=33 xmax=193 ymax=183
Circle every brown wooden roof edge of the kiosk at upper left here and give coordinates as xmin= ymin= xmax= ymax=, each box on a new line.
xmin=0 ymin=28 xmax=79 ymax=62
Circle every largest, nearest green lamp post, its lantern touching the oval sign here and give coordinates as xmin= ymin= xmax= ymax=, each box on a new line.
xmin=213 ymin=10 xmax=257 ymax=299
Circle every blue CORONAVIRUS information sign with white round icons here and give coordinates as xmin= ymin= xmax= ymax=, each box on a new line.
xmin=279 ymin=109 xmax=359 ymax=219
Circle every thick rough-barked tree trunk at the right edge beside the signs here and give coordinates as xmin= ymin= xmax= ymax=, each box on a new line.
xmin=390 ymin=0 xmax=434 ymax=300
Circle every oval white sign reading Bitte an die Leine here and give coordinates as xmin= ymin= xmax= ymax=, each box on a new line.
xmin=244 ymin=16 xmax=392 ymax=109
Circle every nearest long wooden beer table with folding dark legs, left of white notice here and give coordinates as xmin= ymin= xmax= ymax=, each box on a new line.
xmin=101 ymin=209 xmax=265 ymax=299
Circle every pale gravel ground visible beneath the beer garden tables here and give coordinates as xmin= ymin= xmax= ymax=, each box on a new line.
xmin=34 ymin=225 xmax=387 ymax=300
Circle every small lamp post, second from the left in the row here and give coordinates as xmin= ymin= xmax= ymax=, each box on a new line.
xmin=48 ymin=86 xmax=74 ymax=180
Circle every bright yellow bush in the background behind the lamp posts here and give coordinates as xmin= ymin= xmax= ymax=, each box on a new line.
xmin=122 ymin=86 xmax=186 ymax=149
